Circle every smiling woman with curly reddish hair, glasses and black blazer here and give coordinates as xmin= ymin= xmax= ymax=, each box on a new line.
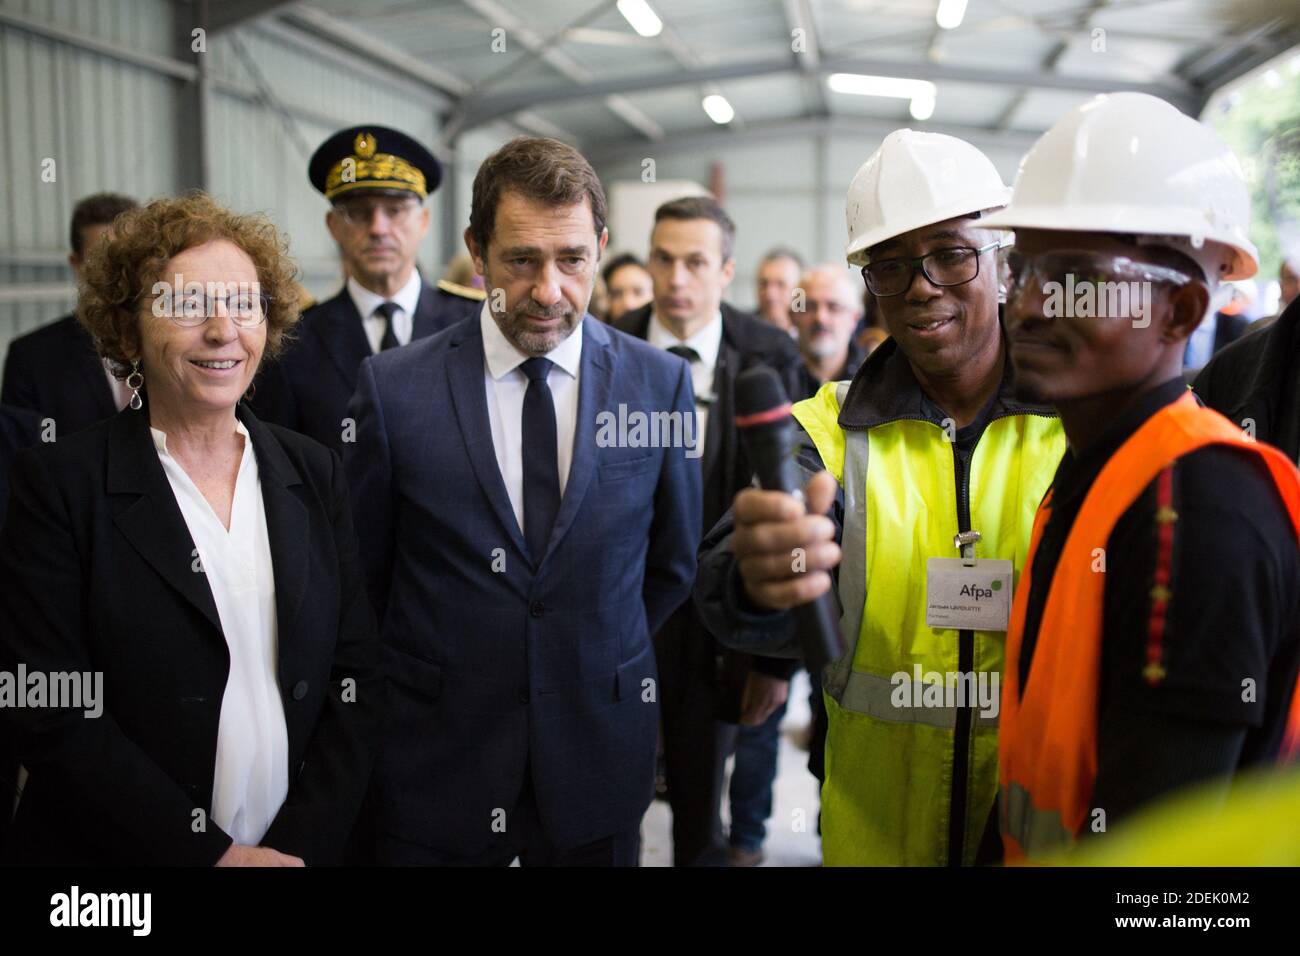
xmin=0 ymin=194 xmax=382 ymax=866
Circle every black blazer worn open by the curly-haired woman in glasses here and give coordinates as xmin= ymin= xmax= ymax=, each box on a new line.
xmin=0 ymin=406 xmax=384 ymax=865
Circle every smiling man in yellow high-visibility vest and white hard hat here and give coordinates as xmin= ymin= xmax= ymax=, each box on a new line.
xmin=696 ymin=130 xmax=1065 ymax=865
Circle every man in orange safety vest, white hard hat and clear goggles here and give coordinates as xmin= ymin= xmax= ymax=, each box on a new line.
xmin=987 ymin=94 xmax=1300 ymax=862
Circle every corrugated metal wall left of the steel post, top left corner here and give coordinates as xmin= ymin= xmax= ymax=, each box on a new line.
xmin=0 ymin=0 xmax=176 ymax=349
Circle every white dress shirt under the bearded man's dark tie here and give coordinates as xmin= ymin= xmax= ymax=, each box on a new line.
xmin=478 ymin=302 xmax=582 ymax=531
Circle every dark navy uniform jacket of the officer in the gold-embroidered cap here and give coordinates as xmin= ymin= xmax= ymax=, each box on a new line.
xmin=250 ymin=282 xmax=482 ymax=454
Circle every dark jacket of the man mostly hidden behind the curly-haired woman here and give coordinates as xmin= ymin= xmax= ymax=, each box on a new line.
xmin=0 ymin=315 xmax=117 ymax=438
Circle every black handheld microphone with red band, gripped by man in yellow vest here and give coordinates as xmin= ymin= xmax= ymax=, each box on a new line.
xmin=736 ymin=365 xmax=844 ymax=674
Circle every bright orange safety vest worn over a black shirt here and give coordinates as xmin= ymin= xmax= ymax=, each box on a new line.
xmin=998 ymin=393 xmax=1300 ymax=862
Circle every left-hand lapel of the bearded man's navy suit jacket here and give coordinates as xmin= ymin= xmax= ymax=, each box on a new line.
xmin=447 ymin=323 xmax=540 ymax=564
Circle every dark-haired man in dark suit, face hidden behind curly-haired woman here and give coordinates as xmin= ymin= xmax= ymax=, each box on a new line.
xmin=0 ymin=193 xmax=137 ymax=438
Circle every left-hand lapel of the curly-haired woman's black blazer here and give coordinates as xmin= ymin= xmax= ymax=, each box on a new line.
xmin=107 ymin=407 xmax=222 ymax=637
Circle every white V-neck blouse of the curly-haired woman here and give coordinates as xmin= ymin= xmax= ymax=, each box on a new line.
xmin=150 ymin=420 xmax=289 ymax=847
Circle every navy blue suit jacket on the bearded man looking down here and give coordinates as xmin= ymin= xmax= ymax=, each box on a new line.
xmin=345 ymin=315 xmax=701 ymax=862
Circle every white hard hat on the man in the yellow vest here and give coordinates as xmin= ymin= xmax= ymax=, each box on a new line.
xmin=845 ymin=130 xmax=1011 ymax=265
